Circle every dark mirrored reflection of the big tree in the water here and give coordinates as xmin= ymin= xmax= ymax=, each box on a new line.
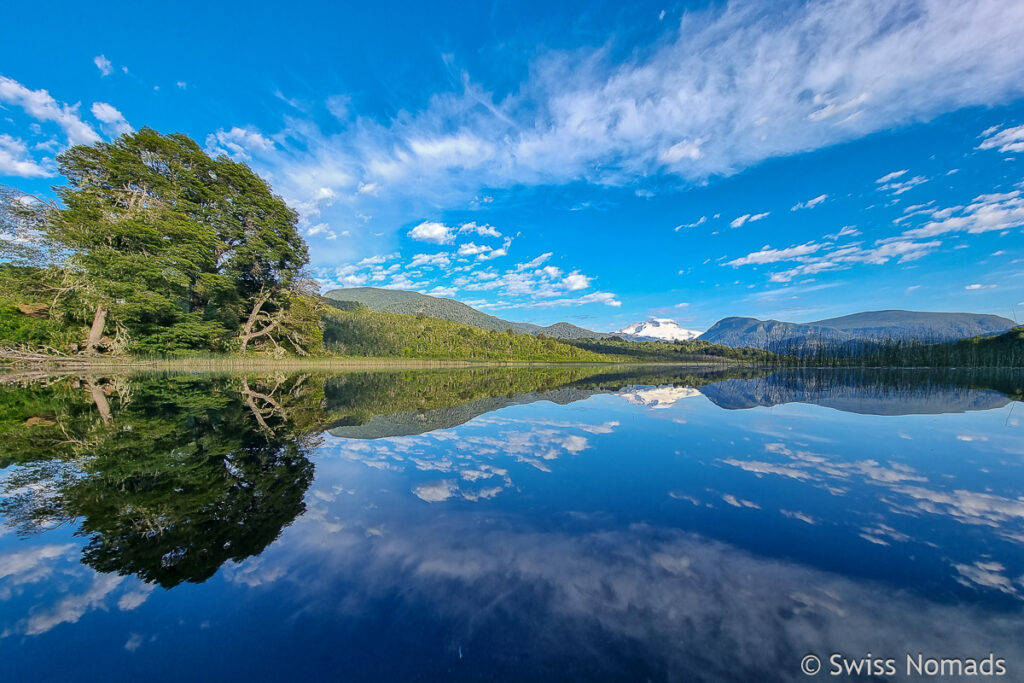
xmin=0 ymin=376 xmax=323 ymax=588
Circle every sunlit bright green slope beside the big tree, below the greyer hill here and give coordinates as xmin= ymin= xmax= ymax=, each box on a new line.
xmin=324 ymin=302 xmax=615 ymax=362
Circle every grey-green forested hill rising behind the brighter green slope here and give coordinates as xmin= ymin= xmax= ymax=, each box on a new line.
xmin=324 ymin=287 xmax=610 ymax=339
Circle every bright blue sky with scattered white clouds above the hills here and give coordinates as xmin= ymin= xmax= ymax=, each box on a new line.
xmin=0 ymin=0 xmax=1024 ymax=330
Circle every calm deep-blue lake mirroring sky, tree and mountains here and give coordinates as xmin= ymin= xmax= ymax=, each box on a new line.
xmin=0 ymin=368 xmax=1024 ymax=683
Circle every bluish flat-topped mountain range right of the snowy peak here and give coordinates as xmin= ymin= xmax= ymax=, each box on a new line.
xmin=699 ymin=310 xmax=1015 ymax=350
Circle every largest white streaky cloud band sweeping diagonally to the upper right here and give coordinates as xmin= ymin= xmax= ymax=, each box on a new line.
xmin=199 ymin=0 xmax=1024 ymax=229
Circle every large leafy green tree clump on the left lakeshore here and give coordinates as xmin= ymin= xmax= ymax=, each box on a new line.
xmin=0 ymin=129 xmax=318 ymax=353
